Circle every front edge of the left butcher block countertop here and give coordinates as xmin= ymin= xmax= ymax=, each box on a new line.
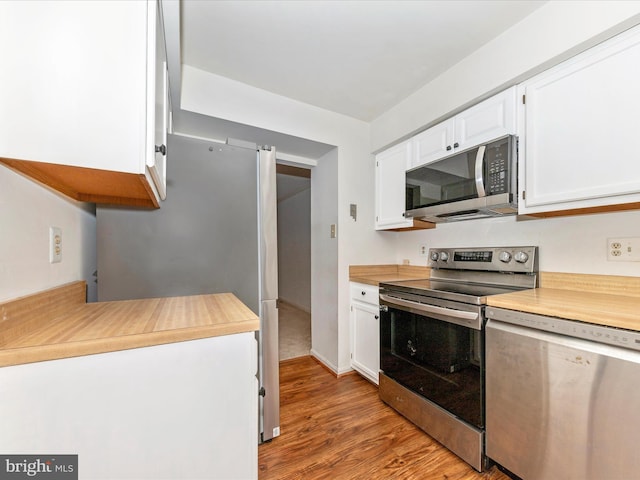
xmin=0 ymin=319 xmax=260 ymax=367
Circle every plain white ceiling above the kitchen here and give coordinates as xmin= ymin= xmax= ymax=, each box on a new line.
xmin=181 ymin=0 xmax=546 ymax=122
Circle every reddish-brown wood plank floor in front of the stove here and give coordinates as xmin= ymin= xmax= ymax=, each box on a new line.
xmin=258 ymin=356 xmax=509 ymax=480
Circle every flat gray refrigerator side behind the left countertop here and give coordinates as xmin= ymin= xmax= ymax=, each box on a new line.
xmin=97 ymin=135 xmax=259 ymax=313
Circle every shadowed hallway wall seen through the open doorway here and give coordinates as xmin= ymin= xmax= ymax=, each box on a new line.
xmin=278 ymin=188 xmax=311 ymax=313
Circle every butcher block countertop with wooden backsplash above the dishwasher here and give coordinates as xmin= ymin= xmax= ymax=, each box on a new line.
xmin=487 ymin=272 xmax=640 ymax=331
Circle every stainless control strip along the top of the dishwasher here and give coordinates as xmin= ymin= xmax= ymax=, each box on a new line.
xmin=485 ymin=307 xmax=640 ymax=351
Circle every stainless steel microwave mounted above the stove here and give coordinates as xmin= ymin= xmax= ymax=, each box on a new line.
xmin=405 ymin=135 xmax=518 ymax=223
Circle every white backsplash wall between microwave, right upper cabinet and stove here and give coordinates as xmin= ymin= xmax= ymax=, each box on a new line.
xmin=396 ymin=207 xmax=640 ymax=276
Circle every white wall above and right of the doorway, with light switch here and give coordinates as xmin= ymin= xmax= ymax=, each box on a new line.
xmin=181 ymin=65 xmax=396 ymax=373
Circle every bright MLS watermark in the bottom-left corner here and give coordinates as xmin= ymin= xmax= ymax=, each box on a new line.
xmin=0 ymin=455 xmax=78 ymax=480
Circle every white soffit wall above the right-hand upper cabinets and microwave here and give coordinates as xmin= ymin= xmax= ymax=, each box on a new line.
xmin=371 ymin=0 xmax=640 ymax=151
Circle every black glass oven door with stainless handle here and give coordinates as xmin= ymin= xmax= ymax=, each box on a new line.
xmin=380 ymin=293 xmax=484 ymax=429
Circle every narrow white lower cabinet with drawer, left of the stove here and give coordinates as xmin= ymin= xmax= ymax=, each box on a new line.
xmin=351 ymin=282 xmax=380 ymax=385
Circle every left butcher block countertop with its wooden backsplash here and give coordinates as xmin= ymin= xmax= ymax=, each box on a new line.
xmin=0 ymin=282 xmax=260 ymax=367
